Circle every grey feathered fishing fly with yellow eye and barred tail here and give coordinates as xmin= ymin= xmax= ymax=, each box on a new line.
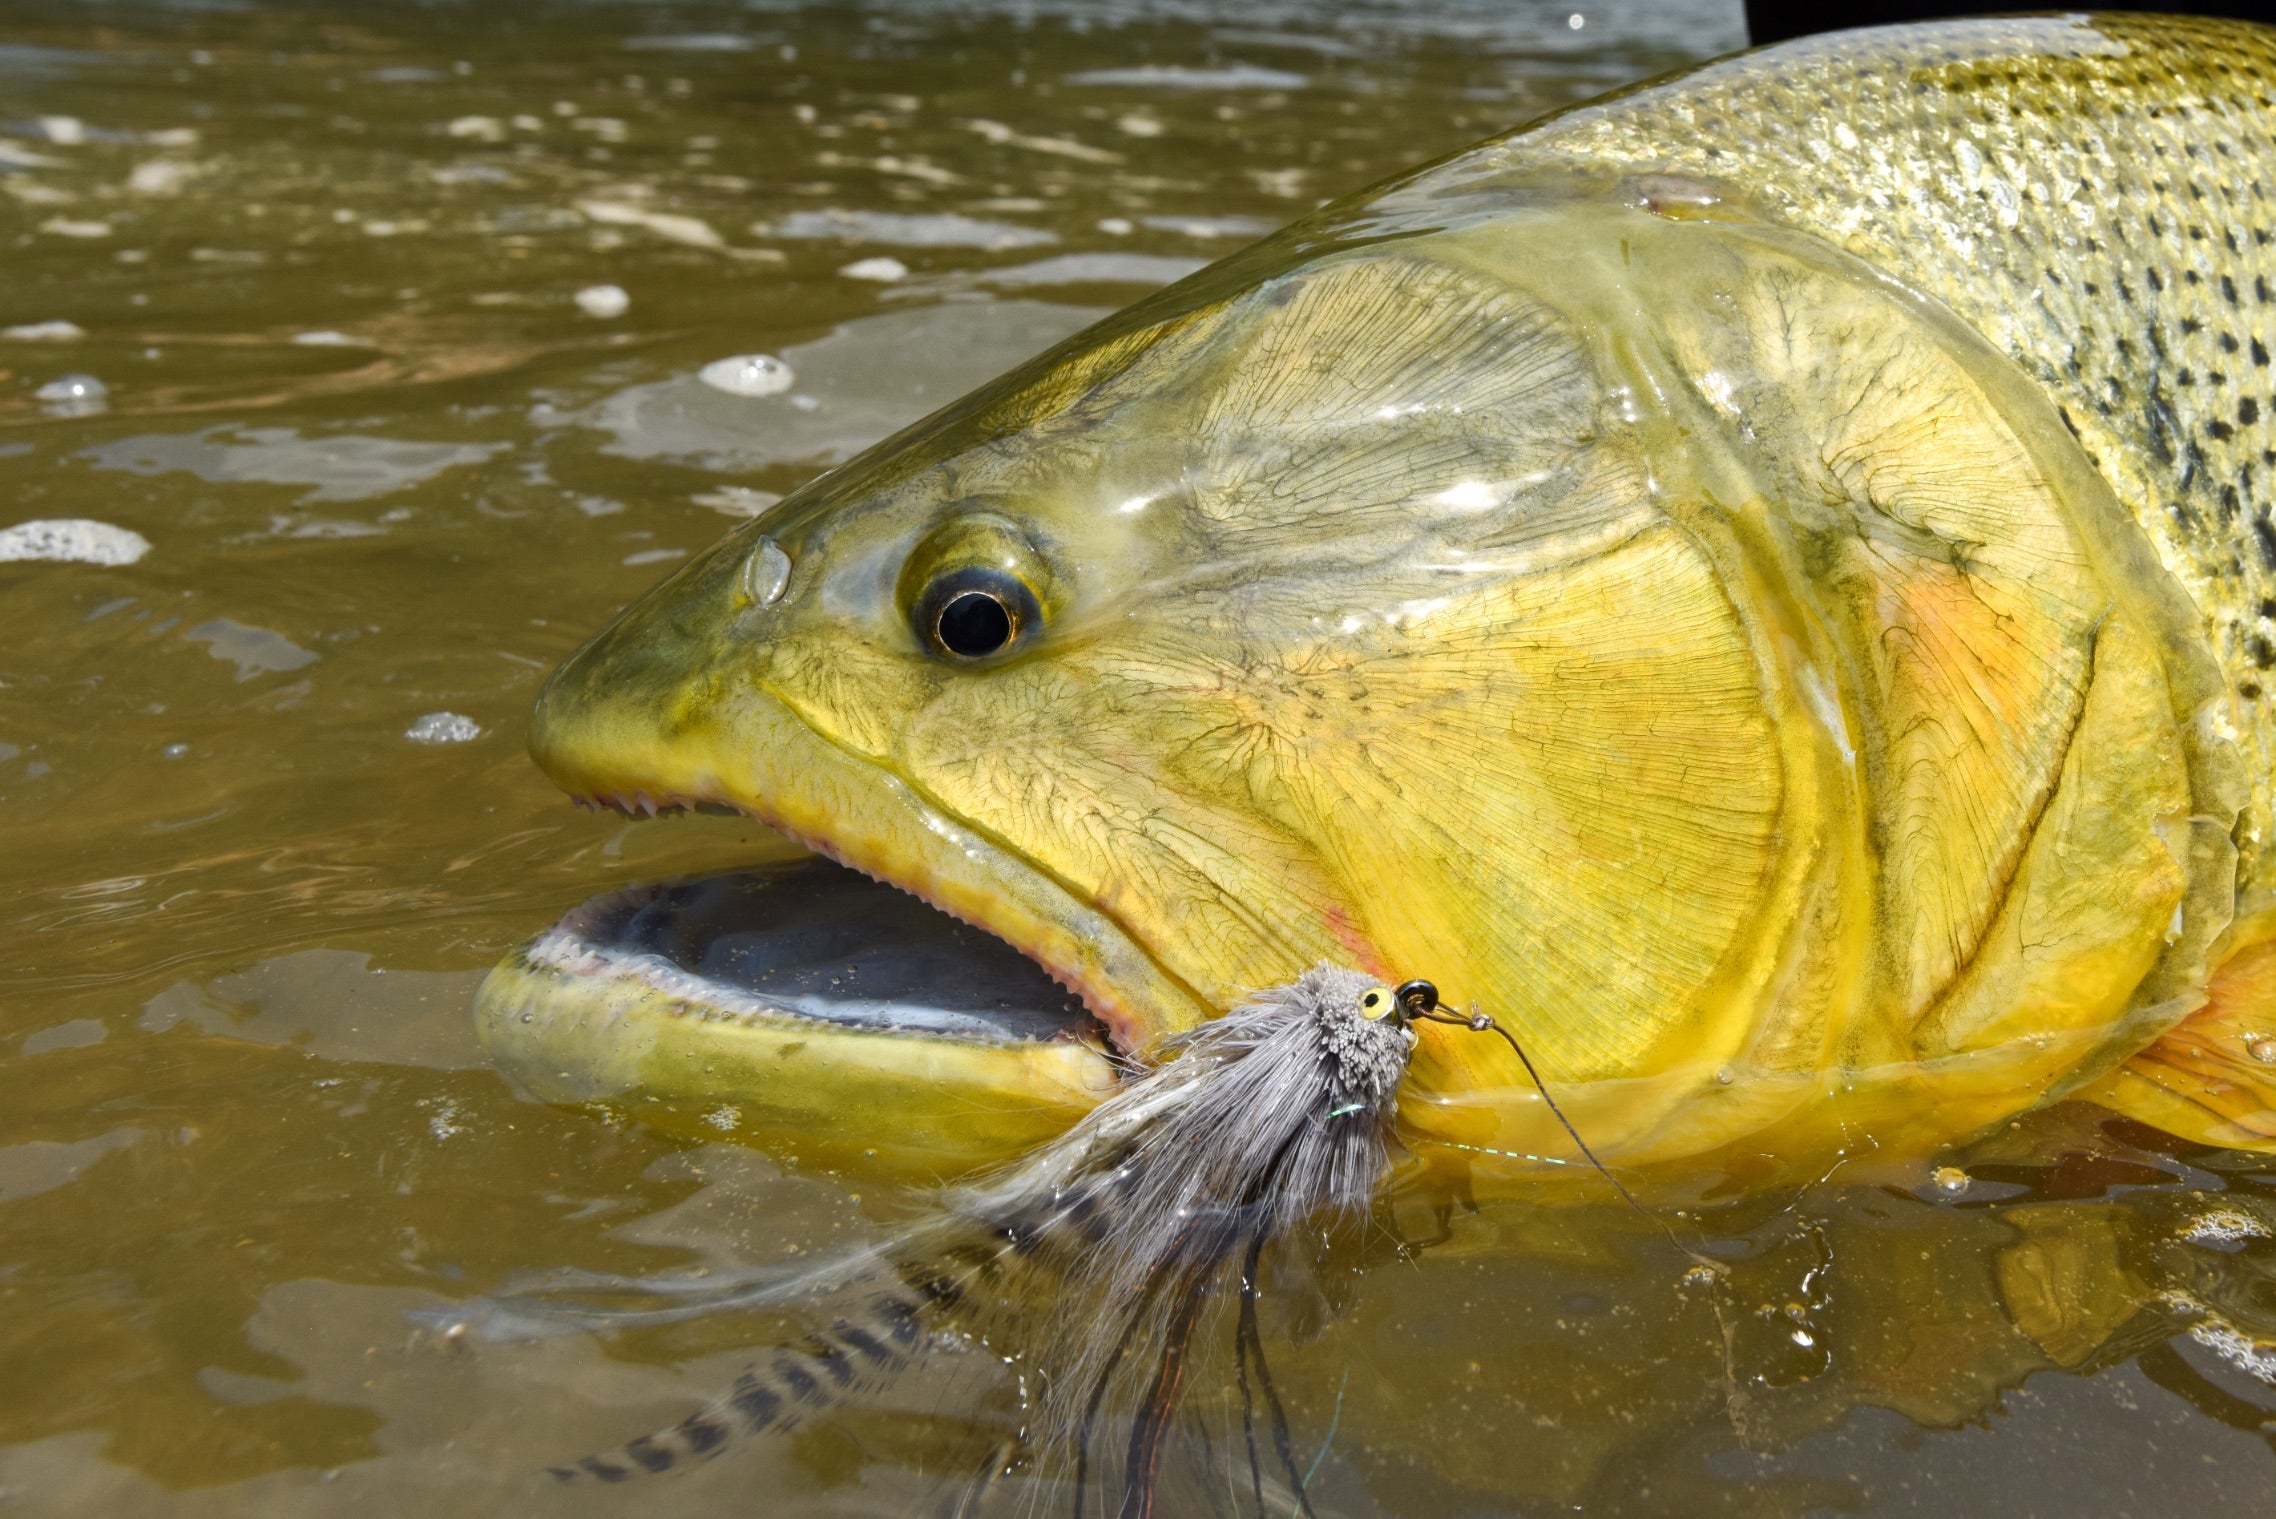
xmin=507 ymin=966 xmax=1641 ymax=1519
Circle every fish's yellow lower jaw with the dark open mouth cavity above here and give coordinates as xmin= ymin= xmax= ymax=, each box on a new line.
xmin=476 ymin=859 xmax=1118 ymax=1168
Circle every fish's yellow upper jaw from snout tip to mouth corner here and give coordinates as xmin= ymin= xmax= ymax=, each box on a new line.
xmin=530 ymin=663 xmax=1215 ymax=1054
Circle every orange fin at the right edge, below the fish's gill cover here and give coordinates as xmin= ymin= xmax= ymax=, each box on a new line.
xmin=2078 ymin=911 xmax=2276 ymax=1152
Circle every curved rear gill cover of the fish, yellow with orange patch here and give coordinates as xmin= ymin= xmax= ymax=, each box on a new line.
xmin=1659 ymin=216 xmax=2192 ymax=1106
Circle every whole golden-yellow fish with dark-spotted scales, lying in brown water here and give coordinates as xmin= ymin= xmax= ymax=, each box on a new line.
xmin=483 ymin=16 xmax=2276 ymax=1187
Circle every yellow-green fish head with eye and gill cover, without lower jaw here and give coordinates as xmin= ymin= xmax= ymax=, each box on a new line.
xmin=530 ymin=184 xmax=2239 ymax=1157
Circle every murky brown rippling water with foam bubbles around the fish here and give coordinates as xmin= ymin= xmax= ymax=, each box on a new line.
xmin=13 ymin=0 xmax=2276 ymax=1514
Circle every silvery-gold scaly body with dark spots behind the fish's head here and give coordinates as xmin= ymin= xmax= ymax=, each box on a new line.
xmin=1450 ymin=16 xmax=2276 ymax=904
